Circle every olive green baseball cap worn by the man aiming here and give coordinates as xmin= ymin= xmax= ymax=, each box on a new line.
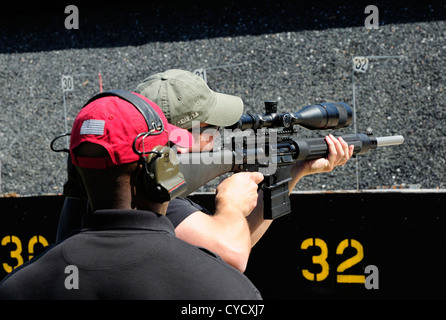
xmin=135 ymin=69 xmax=243 ymax=129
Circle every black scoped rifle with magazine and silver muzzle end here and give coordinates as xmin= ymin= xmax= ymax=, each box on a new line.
xmin=178 ymin=101 xmax=404 ymax=219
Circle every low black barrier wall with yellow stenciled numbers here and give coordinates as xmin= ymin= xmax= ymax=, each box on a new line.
xmin=0 ymin=190 xmax=446 ymax=299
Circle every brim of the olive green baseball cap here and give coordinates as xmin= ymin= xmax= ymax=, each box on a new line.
xmin=204 ymin=92 xmax=243 ymax=127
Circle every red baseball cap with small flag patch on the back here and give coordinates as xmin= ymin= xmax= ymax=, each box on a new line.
xmin=70 ymin=93 xmax=193 ymax=169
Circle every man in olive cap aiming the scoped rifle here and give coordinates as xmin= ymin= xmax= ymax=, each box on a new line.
xmin=135 ymin=69 xmax=353 ymax=272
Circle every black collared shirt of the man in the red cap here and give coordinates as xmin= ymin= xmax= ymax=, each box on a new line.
xmin=0 ymin=210 xmax=261 ymax=299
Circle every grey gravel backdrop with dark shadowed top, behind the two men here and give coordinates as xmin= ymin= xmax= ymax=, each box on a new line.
xmin=0 ymin=0 xmax=446 ymax=196
